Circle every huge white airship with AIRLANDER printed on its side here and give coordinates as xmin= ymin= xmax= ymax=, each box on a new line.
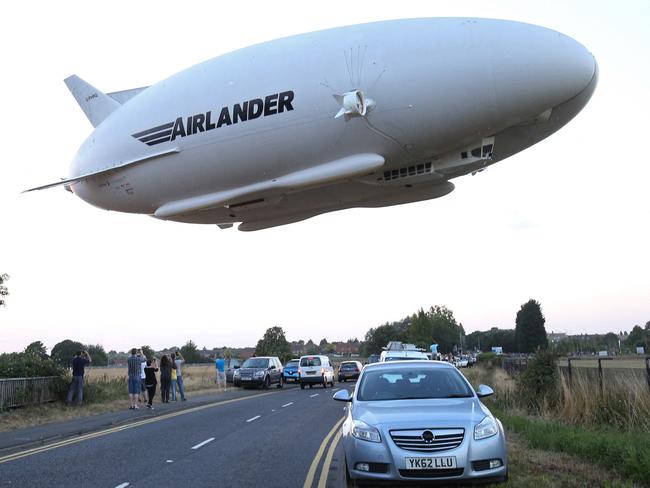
xmin=27 ymin=18 xmax=598 ymax=231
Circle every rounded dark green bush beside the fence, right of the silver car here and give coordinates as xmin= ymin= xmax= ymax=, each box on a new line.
xmin=516 ymin=351 xmax=559 ymax=413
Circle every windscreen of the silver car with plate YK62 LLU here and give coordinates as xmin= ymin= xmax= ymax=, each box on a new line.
xmin=357 ymin=365 xmax=473 ymax=401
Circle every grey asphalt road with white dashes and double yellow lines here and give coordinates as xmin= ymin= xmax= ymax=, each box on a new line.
xmin=0 ymin=383 xmax=353 ymax=488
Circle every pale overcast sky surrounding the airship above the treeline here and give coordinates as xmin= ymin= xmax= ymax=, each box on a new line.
xmin=0 ymin=0 xmax=650 ymax=352
